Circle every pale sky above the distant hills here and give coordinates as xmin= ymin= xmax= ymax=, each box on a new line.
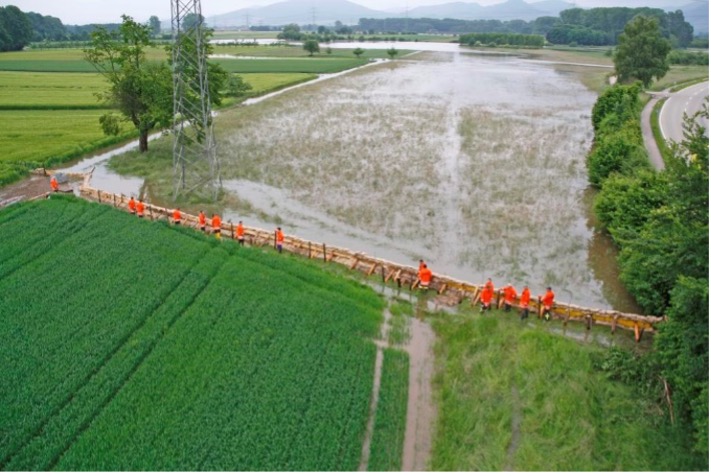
xmin=0 ymin=0 xmax=694 ymax=25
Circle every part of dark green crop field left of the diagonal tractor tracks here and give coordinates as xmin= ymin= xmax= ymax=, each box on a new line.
xmin=0 ymin=199 xmax=211 ymax=464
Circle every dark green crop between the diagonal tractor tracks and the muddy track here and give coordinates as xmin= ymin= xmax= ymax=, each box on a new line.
xmin=57 ymin=251 xmax=384 ymax=470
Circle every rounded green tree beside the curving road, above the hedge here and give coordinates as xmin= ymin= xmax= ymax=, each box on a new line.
xmin=613 ymin=15 xmax=671 ymax=87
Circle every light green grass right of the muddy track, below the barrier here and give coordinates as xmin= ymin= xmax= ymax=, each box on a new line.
xmin=431 ymin=310 xmax=695 ymax=471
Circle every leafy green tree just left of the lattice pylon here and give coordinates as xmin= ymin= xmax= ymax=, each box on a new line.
xmin=84 ymin=15 xmax=173 ymax=152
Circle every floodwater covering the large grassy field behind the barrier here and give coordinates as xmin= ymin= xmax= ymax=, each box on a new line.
xmin=58 ymin=43 xmax=637 ymax=312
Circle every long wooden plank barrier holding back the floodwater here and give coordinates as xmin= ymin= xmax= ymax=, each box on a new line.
xmin=80 ymin=181 xmax=666 ymax=342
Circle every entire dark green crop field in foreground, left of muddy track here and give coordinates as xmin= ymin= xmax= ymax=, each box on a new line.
xmin=0 ymin=196 xmax=407 ymax=471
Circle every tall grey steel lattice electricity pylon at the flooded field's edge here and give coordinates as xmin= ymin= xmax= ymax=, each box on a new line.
xmin=170 ymin=0 xmax=222 ymax=200
